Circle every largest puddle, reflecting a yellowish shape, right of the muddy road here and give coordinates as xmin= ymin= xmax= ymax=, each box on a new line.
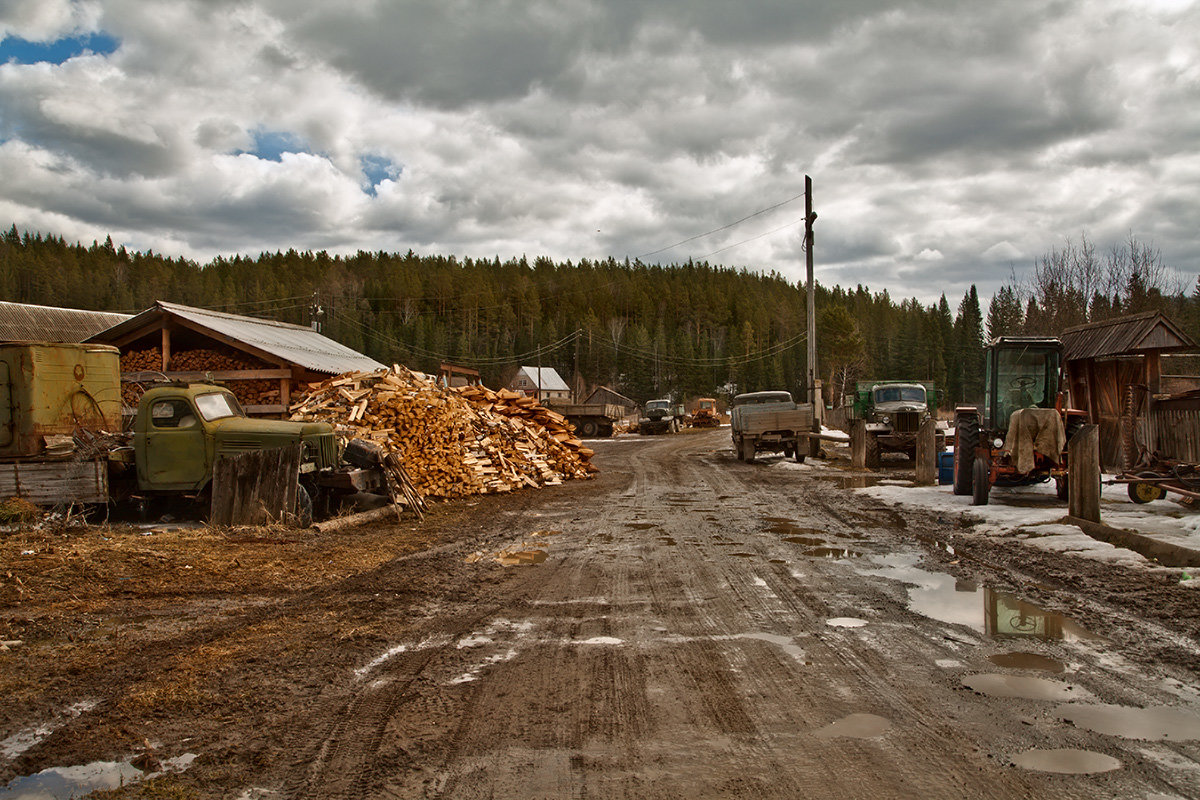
xmin=865 ymin=553 xmax=1099 ymax=642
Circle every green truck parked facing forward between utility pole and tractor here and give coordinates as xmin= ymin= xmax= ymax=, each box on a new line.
xmin=850 ymin=380 xmax=946 ymax=468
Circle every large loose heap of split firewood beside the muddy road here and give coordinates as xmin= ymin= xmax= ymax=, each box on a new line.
xmin=290 ymin=366 xmax=596 ymax=498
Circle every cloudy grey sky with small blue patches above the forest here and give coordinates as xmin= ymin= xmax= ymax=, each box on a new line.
xmin=0 ymin=0 xmax=1200 ymax=302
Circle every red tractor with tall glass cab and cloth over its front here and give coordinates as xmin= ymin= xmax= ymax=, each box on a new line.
xmin=954 ymin=336 xmax=1087 ymax=505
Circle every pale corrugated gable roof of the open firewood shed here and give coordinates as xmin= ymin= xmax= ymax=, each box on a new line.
xmin=91 ymin=300 xmax=385 ymax=375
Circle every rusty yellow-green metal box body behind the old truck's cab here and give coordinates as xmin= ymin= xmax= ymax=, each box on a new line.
xmin=0 ymin=342 xmax=121 ymax=458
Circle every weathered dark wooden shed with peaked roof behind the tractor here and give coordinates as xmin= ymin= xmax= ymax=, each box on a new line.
xmin=1061 ymin=312 xmax=1200 ymax=470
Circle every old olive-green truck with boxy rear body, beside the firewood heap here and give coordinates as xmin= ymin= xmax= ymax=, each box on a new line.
xmin=0 ymin=344 xmax=382 ymax=522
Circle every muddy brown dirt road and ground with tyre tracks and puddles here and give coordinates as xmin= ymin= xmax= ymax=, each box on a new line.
xmin=0 ymin=429 xmax=1200 ymax=800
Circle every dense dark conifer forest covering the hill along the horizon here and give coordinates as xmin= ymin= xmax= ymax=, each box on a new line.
xmin=0 ymin=225 xmax=1198 ymax=403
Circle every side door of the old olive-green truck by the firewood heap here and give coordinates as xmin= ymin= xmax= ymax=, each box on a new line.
xmin=138 ymin=397 xmax=209 ymax=489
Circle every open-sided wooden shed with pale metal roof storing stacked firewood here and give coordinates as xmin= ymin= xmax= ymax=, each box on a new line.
xmin=88 ymin=301 xmax=384 ymax=415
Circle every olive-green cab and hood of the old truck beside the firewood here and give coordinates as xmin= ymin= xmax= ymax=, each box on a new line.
xmin=133 ymin=384 xmax=337 ymax=492
